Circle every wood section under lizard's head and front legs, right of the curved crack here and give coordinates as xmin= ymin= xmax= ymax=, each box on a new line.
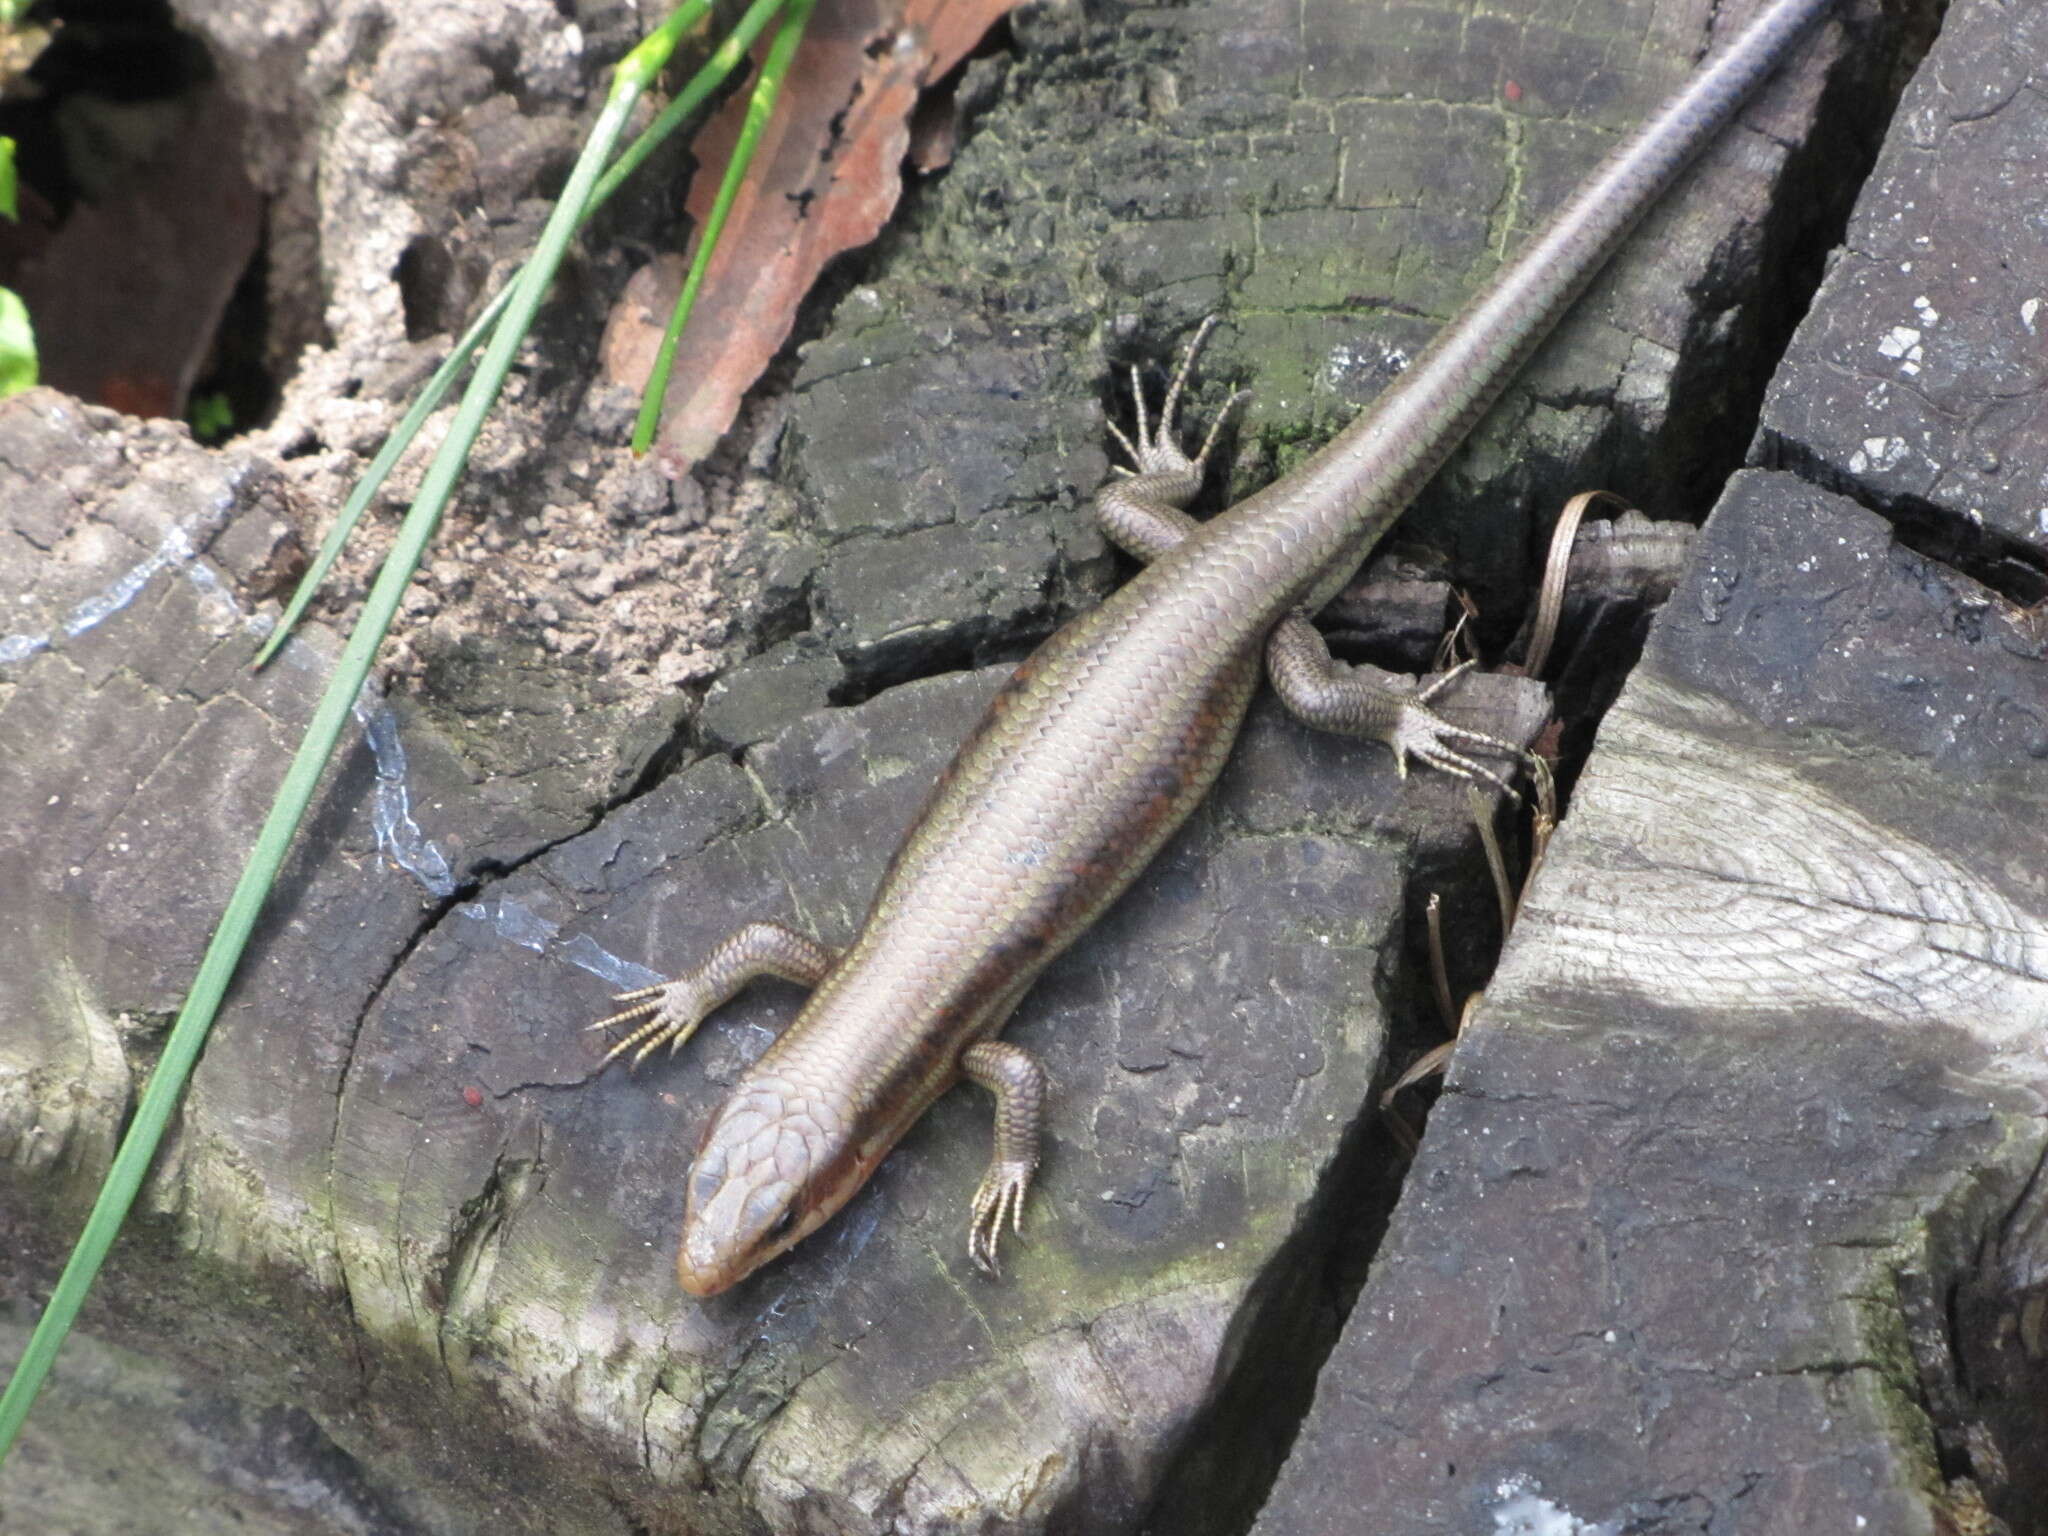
xmin=323 ymin=668 xmax=1540 ymax=1532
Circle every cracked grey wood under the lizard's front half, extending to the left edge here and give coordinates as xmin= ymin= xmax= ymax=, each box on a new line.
xmin=0 ymin=391 xmax=1534 ymax=1530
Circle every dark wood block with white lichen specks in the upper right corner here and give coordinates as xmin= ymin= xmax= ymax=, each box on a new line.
xmin=1761 ymin=4 xmax=2048 ymax=602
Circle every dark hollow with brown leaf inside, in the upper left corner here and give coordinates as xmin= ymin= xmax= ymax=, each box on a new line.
xmin=0 ymin=0 xmax=279 ymax=442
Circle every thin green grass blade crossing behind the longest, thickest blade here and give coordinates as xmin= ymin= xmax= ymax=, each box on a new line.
xmin=250 ymin=0 xmax=784 ymax=668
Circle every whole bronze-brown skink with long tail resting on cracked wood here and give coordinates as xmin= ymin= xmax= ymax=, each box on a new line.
xmin=604 ymin=0 xmax=1829 ymax=1296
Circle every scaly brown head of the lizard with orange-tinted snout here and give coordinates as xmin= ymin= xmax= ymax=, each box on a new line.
xmin=676 ymin=1079 xmax=866 ymax=1296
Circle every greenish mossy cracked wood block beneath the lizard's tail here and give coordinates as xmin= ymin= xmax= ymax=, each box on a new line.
xmin=705 ymin=0 xmax=1870 ymax=729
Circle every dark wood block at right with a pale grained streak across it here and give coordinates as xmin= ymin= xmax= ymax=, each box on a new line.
xmin=1257 ymin=473 xmax=2048 ymax=1536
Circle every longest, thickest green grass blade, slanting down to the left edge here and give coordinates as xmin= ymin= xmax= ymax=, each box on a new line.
xmin=0 ymin=45 xmax=659 ymax=1460
